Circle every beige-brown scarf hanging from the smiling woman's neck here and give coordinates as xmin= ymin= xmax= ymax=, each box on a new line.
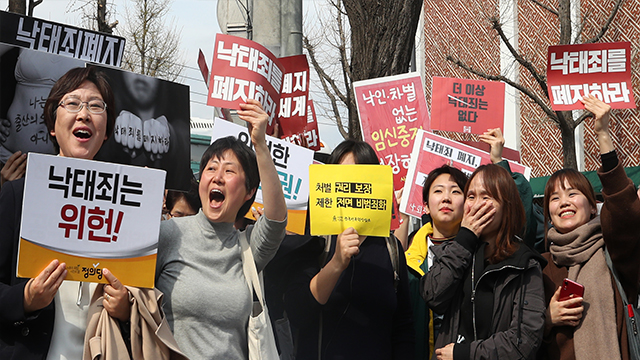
xmin=547 ymin=217 xmax=621 ymax=360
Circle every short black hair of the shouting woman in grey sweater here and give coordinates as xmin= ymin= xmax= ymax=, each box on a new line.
xmin=200 ymin=136 xmax=260 ymax=220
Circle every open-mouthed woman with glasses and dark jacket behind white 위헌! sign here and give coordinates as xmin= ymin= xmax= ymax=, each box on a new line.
xmin=0 ymin=67 xmax=131 ymax=359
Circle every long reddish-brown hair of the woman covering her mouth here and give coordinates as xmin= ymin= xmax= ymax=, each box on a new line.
xmin=464 ymin=164 xmax=527 ymax=264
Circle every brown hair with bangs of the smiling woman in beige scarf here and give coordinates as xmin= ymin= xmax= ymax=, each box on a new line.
xmin=543 ymin=169 xmax=597 ymax=248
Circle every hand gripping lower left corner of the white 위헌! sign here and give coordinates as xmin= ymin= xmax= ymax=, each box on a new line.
xmin=24 ymin=260 xmax=67 ymax=313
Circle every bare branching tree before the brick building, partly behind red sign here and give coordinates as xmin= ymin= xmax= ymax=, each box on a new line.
xmin=446 ymin=0 xmax=624 ymax=169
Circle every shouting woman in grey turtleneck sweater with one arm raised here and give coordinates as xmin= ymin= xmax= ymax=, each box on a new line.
xmin=156 ymin=100 xmax=287 ymax=360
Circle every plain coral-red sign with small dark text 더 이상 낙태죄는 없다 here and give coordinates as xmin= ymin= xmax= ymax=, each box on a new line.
xmin=431 ymin=76 xmax=504 ymax=134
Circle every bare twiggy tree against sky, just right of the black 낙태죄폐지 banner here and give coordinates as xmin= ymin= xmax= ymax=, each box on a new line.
xmin=123 ymin=0 xmax=184 ymax=81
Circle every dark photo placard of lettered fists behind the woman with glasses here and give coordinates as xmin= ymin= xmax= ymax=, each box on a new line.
xmin=96 ymin=67 xmax=192 ymax=191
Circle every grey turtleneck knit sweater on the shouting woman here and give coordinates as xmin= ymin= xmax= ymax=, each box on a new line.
xmin=156 ymin=210 xmax=287 ymax=360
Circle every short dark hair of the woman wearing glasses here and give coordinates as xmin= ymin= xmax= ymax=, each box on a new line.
xmin=44 ymin=65 xmax=116 ymax=152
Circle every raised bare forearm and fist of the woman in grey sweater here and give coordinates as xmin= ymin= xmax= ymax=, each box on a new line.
xmin=238 ymin=99 xmax=287 ymax=221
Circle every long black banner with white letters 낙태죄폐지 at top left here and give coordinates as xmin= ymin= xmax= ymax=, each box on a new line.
xmin=0 ymin=11 xmax=125 ymax=67
